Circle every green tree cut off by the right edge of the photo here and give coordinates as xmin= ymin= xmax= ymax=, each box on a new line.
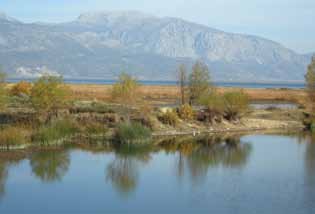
xmin=305 ymin=56 xmax=315 ymax=111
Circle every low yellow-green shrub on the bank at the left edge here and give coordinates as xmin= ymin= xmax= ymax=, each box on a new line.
xmin=0 ymin=127 xmax=30 ymax=146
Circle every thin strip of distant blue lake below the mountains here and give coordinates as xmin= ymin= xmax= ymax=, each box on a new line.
xmin=8 ymin=78 xmax=305 ymax=89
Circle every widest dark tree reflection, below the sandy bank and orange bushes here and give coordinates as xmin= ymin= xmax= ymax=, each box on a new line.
xmin=161 ymin=136 xmax=252 ymax=181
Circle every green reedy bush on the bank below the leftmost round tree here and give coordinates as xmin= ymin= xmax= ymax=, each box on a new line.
xmin=33 ymin=119 xmax=80 ymax=143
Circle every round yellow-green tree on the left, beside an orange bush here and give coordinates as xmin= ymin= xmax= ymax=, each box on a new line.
xmin=31 ymin=76 xmax=70 ymax=119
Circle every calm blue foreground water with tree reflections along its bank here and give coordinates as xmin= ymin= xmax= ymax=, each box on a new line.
xmin=0 ymin=135 xmax=315 ymax=214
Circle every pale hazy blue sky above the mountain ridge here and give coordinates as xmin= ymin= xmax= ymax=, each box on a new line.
xmin=0 ymin=0 xmax=315 ymax=53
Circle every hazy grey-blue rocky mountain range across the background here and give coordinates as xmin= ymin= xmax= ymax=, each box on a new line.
xmin=0 ymin=11 xmax=311 ymax=81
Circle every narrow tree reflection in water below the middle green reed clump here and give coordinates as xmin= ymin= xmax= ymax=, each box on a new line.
xmin=106 ymin=146 xmax=152 ymax=196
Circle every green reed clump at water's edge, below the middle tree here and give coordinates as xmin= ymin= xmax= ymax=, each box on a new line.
xmin=115 ymin=123 xmax=151 ymax=144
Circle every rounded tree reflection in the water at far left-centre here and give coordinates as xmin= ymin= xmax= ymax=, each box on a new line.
xmin=30 ymin=150 xmax=70 ymax=183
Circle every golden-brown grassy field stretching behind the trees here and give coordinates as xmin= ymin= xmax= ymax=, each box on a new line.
xmin=69 ymin=84 xmax=307 ymax=104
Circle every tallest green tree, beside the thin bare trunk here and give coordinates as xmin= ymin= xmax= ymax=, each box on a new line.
xmin=188 ymin=61 xmax=211 ymax=105
